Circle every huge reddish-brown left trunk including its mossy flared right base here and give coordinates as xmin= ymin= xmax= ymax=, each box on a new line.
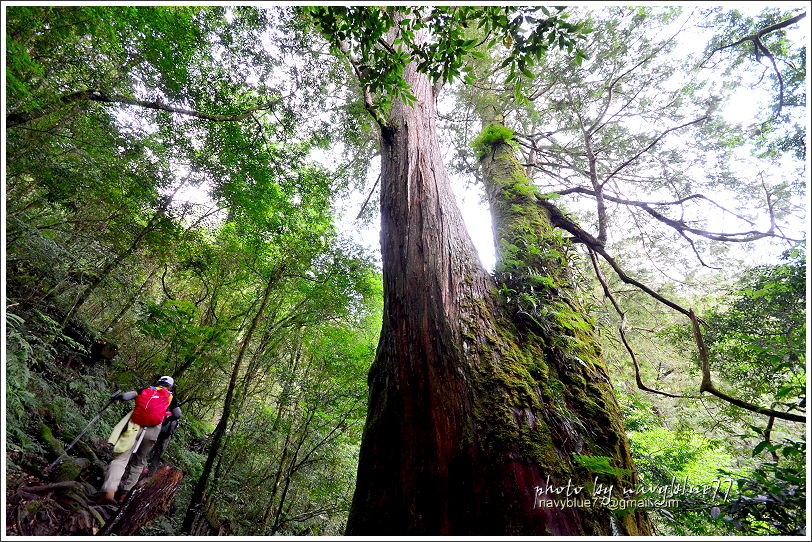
xmin=347 ymin=45 xmax=650 ymax=535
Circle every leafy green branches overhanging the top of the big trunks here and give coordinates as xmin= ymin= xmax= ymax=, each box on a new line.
xmin=300 ymin=6 xmax=588 ymax=110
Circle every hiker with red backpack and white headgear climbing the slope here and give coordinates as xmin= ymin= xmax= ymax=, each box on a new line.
xmin=101 ymin=376 xmax=181 ymax=503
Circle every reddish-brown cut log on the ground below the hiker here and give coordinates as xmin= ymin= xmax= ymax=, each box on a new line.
xmin=98 ymin=465 xmax=183 ymax=536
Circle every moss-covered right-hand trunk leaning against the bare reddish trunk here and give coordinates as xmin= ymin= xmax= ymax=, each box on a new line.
xmin=477 ymin=126 xmax=651 ymax=534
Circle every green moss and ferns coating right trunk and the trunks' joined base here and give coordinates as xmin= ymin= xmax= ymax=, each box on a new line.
xmin=471 ymin=123 xmax=652 ymax=532
